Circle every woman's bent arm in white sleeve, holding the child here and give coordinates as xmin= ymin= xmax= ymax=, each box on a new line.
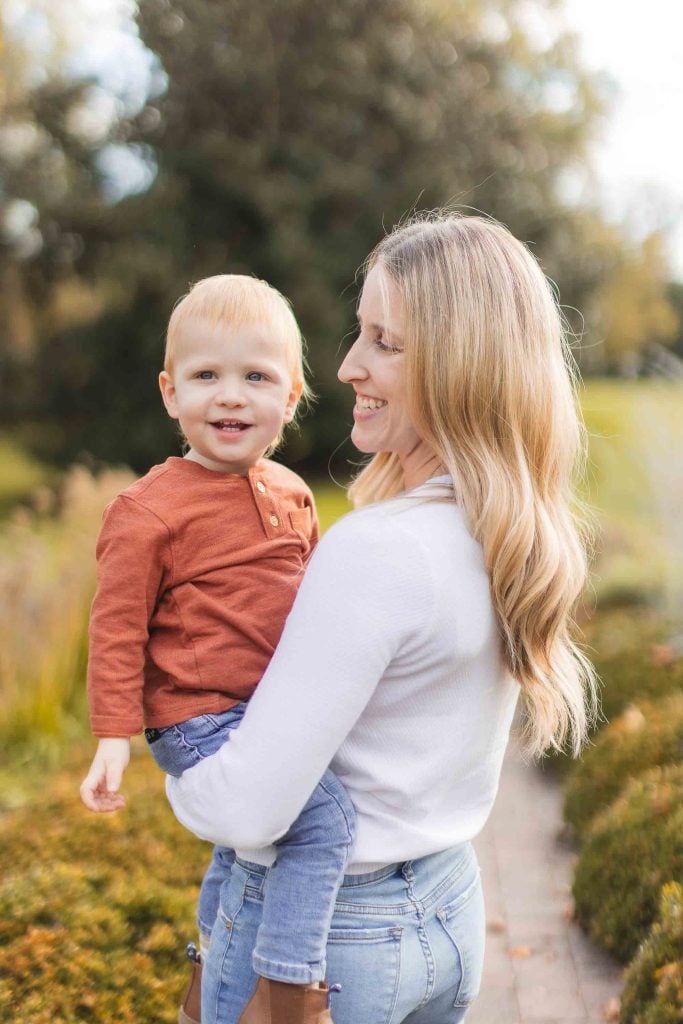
xmin=167 ymin=513 xmax=433 ymax=850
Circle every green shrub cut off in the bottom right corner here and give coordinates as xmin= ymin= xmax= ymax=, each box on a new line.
xmin=620 ymin=883 xmax=683 ymax=1024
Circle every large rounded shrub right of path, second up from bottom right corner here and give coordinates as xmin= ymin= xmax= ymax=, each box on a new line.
xmin=573 ymin=765 xmax=683 ymax=963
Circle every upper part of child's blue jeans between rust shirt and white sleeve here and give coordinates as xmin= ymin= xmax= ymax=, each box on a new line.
xmin=144 ymin=701 xmax=247 ymax=777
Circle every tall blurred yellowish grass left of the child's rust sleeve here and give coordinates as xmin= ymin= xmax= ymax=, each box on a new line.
xmin=0 ymin=468 xmax=132 ymax=788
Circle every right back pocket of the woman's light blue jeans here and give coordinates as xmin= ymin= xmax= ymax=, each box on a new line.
xmin=436 ymin=876 xmax=485 ymax=1007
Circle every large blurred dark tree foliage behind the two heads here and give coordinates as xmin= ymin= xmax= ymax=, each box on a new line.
xmin=0 ymin=0 xmax=673 ymax=470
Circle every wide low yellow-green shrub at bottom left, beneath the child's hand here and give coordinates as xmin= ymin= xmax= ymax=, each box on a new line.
xmin=0 ymin=756 xmax=209 ymax=1024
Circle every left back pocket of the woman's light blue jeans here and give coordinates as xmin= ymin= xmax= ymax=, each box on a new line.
xmin=326 ymin=924 xmax=403 ymax=1024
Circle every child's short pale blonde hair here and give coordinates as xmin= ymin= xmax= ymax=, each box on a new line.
xmin=164 ymin=273 xmax=312 ymax=419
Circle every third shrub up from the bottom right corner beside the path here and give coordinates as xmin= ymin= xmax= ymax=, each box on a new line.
xmin=564 ymin=693 xmax=683 ymax=836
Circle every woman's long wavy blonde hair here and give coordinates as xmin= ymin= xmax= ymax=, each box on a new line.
xmin=350 ymin=212 xmax=597 ymax=755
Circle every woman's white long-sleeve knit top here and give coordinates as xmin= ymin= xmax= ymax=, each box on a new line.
xmin=167 ymin=477 xmax=519 ymax=872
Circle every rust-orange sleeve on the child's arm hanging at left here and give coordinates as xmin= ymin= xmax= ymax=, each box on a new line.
xmin=88 ymin=495 xmax=171 ymax=736
